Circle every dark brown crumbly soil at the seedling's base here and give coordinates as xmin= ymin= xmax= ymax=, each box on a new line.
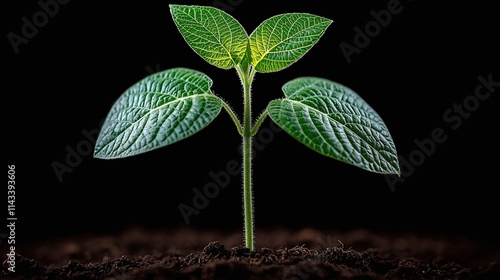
xmin=0 ymin=227 xmax=500 ymax=280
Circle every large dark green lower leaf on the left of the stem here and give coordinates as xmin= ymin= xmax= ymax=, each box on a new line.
xmin=94 ymin=68 xmax=222 ymax=159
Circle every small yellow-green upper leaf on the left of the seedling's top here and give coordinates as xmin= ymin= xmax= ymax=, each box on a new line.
xmin=170 ymin=5 xmax=248 ymax=69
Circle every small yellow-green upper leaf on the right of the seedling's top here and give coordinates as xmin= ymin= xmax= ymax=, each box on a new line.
xmin=250 ymin=13 xmax=333 ymax=72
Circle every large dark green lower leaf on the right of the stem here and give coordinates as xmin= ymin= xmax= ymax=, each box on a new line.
xmin=267 ymin=77 xmax=400 ymax=174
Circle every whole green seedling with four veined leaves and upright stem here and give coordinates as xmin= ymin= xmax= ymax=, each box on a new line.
xmin=94 ymin=5 xmax=400 ymax=250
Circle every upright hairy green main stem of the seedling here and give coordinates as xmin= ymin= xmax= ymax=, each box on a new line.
xmin=237 ymin=68 xmax=255 ymax=251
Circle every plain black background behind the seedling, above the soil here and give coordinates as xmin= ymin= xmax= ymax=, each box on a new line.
xmin=0 ymin=0 xmax=500 ymax=249
